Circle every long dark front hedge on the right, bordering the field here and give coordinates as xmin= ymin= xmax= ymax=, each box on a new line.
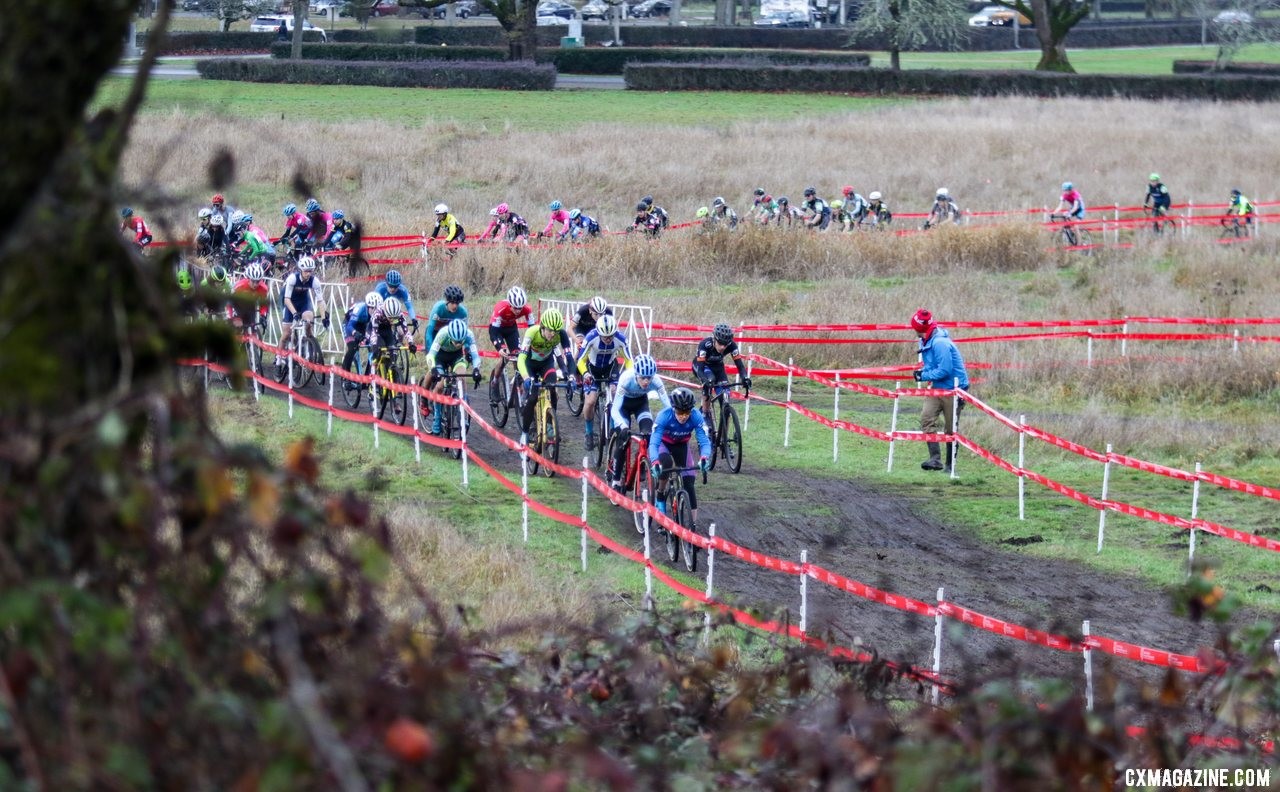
xmin=623 ymin=64 xmax=1280 ymax=101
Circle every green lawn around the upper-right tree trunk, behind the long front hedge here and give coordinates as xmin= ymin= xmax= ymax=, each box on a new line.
xmin=872 ymin=43 xmax=1280 ymax=74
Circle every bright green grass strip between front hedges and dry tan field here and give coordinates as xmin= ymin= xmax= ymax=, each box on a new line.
xmin=92 ymin=78 xmax=909 ymax=128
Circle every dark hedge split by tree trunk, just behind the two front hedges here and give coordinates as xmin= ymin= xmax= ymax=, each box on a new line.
xmin=271 ymin=42 xmax=872 ymax=74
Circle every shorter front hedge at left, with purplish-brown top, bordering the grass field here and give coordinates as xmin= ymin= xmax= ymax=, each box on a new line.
xmin=196 ymin=59 xmax=556 ymax=91
